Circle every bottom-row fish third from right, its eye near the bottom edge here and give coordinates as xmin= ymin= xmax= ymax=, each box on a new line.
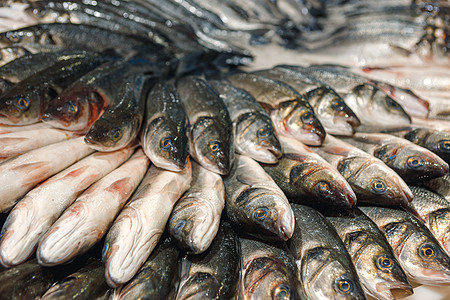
xmin=288 ymin=204 xmax=366 ymax=299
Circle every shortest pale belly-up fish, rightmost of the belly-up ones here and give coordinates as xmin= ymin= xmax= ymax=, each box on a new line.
xmin=167 ymin=162 xmax=225 ymax=254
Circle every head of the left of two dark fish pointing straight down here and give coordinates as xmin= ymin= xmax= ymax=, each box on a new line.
xmin=143 ymin=116 xmax=189 ymax=172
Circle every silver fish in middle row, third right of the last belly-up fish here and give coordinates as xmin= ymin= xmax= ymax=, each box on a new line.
xmin=311 ymin=136 xmax=412 ymax=206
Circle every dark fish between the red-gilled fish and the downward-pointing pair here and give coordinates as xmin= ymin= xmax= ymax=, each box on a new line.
xmin=84 ymin=74 xmax=153 ymax=152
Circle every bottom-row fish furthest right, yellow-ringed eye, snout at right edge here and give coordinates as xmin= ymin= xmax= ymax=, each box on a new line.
xmin=360 ymin=207 xmax=450 ymax=285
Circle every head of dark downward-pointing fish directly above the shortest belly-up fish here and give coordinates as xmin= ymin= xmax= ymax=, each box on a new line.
xmin=191 ymin=117 xmax=234 ymax=175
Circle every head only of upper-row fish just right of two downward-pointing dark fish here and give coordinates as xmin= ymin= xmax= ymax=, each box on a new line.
xmin=235 ymin=113 xmax=282 ymax=164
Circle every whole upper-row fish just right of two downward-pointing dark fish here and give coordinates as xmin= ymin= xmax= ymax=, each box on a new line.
xmin=208 ymin=79 xmax=282 ymax=164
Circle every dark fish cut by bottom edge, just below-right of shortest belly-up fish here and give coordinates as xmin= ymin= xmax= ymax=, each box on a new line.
xmin=174 ymin=222 xmax=239 ymax=300
